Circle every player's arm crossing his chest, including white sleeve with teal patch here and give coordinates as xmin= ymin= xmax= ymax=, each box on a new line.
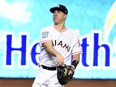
xmin=40 ymin=29 xmax=64 ymax=64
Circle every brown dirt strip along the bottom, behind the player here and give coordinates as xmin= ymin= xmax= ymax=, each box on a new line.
xmin=0 ymin=79 xmax=116 ymax=87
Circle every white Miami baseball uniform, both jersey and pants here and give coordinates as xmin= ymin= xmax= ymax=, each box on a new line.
xmin=33 ymin=25 xmax=81 ymax=87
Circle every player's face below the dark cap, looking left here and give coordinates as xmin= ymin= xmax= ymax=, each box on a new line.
xmin=53 ymin=10 xmax=67 ymax=24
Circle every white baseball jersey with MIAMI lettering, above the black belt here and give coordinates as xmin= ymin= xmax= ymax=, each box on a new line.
xmin=39 ymin=26 xmax=81 ymax=67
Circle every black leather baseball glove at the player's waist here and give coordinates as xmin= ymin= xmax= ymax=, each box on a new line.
xmin=57 ymin=65 xmax=74 ymax=85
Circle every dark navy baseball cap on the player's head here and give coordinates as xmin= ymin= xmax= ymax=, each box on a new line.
xmin=50 ymin=4 xmax=68 ymax=14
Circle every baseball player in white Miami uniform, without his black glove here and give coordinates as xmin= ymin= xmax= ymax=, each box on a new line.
xmin=32 ymin=4 xmax=82 ymax=87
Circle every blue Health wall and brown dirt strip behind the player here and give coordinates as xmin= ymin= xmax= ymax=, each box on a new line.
xmin=0 ymin=0 xmax=116 ymax=87
